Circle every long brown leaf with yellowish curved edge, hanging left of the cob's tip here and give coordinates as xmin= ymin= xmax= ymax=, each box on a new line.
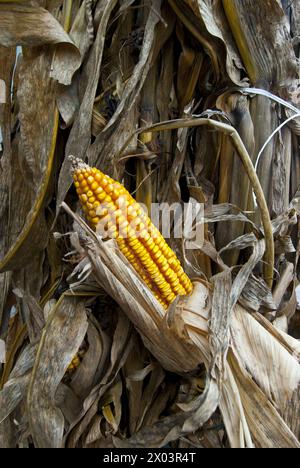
xmin=0 ymin=48 xmax=58 ymax=271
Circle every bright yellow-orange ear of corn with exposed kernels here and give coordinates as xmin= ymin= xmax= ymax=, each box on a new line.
xmin=70 ymin=156 xmax=193 ymax=308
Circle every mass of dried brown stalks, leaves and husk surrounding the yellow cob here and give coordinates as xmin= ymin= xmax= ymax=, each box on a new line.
xmin=0 ymin=0 xmax=300 ymax=448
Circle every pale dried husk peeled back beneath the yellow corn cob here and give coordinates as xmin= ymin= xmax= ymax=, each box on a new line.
xmin=62 ymin=204 xmax=300 ymax=447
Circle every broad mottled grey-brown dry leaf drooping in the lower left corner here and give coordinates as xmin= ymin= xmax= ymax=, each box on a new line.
xmin=27 ymin=296 xmax=88 ymax=448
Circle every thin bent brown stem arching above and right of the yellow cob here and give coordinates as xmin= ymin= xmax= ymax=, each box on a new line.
xmin=118 ymin=117 xmax=275 ymax=288
